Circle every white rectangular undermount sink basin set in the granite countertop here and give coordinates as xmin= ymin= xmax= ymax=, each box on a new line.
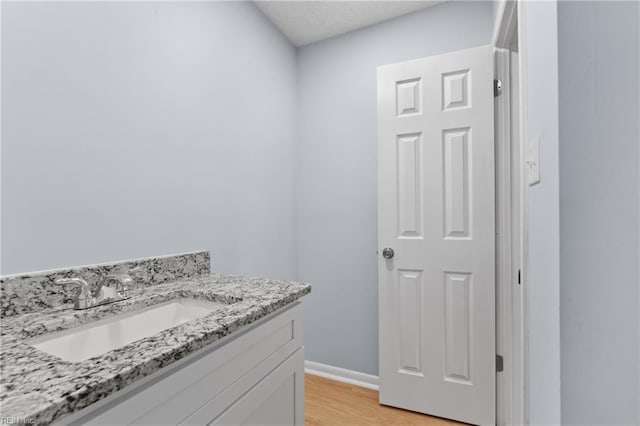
xmin=28 ymin=299 xmax=228 ymax=362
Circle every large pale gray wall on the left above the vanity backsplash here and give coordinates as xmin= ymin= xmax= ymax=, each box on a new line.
xmin=1 ymin=2 xmax=296 ymax=278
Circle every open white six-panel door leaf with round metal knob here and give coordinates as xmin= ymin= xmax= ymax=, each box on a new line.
xmin=378 ymin=46 xmax=496 ymax=424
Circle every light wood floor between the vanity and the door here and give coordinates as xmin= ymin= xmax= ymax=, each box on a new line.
xmin=305 ymin=374 xmax=462 ymax=426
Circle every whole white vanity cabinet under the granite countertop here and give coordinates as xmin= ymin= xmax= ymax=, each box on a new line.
xmin=58 ymin=302 xmax=304 ymax=425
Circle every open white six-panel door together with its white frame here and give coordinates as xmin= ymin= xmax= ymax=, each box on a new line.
xmin=378 ymin=2 xmax=527 ymax=425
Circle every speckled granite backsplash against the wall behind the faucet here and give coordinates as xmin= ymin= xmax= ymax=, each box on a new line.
xmin=0 ymin=251 xmax=211 ymax=317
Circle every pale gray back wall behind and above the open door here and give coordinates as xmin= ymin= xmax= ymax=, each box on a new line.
xmin=296 ymin=2 xmax=493 ymax=374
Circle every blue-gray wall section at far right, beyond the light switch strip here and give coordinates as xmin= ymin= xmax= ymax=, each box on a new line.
xmin=558 ymin=2 xmax=640 ymax=424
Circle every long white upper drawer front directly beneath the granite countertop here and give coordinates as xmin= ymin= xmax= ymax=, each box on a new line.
xmin=80 ymin=305 xmax=302 ymax=425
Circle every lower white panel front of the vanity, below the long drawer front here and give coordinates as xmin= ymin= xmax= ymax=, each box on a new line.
xmin=181 ymin=348 xmax=304 ymax=426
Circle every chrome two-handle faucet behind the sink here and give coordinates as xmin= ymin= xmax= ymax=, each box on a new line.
xmin=56 ymin=274 xmax=133 ymax=309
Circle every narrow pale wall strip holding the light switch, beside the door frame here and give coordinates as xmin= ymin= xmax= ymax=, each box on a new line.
xmin=518 ymin=0 xmax=561 ymax=425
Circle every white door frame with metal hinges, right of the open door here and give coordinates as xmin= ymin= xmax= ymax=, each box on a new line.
xmin=492 ymin=0 xmax=529 ymax=425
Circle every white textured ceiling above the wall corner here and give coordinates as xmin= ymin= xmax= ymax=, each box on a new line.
xmin=255 ymin=0 xmax=443 ymax=46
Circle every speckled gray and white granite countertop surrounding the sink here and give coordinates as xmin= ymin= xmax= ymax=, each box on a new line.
xmin=0 ymin=275 xmax=311 ymax=424
